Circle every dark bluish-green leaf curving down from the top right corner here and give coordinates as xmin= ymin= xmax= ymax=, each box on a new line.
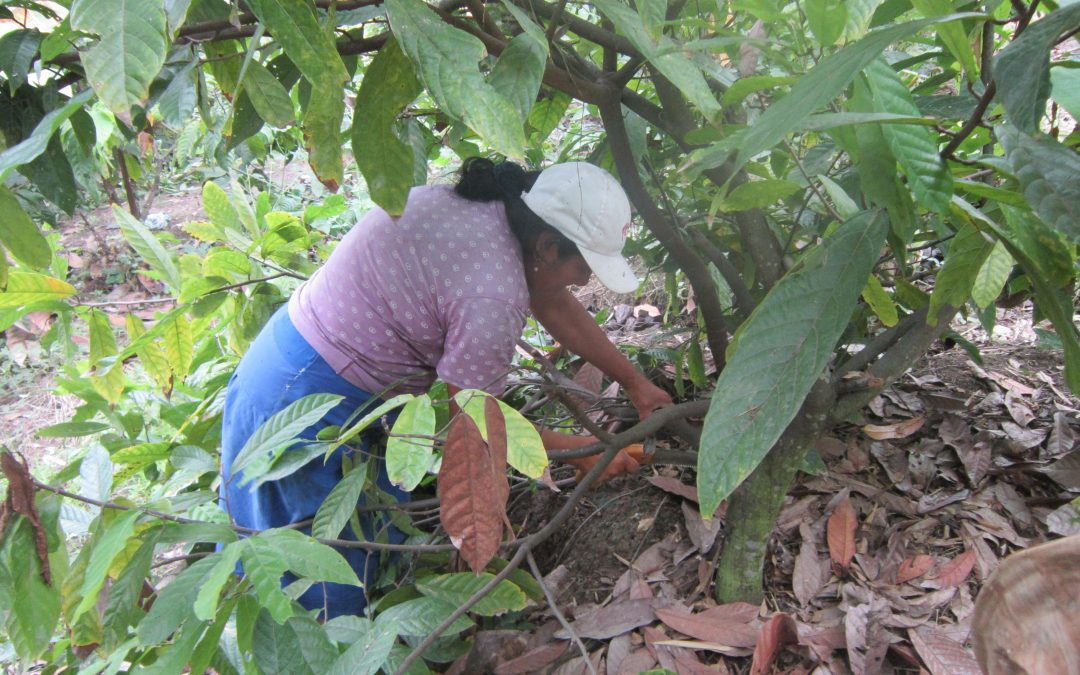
xmin=994 ymin=3 xmax=1080 ymax=134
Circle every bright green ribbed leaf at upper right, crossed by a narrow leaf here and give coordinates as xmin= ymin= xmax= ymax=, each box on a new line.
xmin=866 ymin=59 xmax=953 ymax=213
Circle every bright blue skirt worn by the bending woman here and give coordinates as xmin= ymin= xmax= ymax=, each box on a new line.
xmin=218 ymin=307 xmax=408 ymax=619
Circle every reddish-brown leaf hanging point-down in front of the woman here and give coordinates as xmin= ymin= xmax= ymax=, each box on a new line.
xmin=438 ymin=414 xmax=508 ymax=573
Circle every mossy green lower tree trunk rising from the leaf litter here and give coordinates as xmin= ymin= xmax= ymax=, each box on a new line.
xmin=716 ymin=380 xmax=835 ymax=605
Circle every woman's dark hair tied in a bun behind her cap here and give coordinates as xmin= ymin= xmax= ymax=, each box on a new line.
xmin=454 ymin=157 xmax=580 ymax=258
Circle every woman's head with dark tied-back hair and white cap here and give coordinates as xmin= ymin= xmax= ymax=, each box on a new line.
xmin=455 ymin=158 xmax=637 ymax=293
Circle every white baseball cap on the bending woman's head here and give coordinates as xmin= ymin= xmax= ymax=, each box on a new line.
xmin=522 ymin=162 xmax=637 ymax=293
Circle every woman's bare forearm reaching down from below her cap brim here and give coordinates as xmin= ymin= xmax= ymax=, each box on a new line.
xmin=530 ymin=288 xmax=672 ymax=419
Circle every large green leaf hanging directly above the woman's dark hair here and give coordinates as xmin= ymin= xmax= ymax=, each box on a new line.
xmin=384 ymin=0 xmax=525 ymax=160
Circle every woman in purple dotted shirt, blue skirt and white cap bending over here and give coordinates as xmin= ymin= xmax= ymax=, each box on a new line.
xmin=220 ymin=158 xmax=671 ymax=618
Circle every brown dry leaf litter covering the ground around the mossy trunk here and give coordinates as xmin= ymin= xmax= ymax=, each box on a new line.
xmin=494 ymin=326 xmax=1080 ymax=675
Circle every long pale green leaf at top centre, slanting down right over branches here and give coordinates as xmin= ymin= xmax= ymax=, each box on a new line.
xmin=594 ymin=0 xmax=720 ymax=120
